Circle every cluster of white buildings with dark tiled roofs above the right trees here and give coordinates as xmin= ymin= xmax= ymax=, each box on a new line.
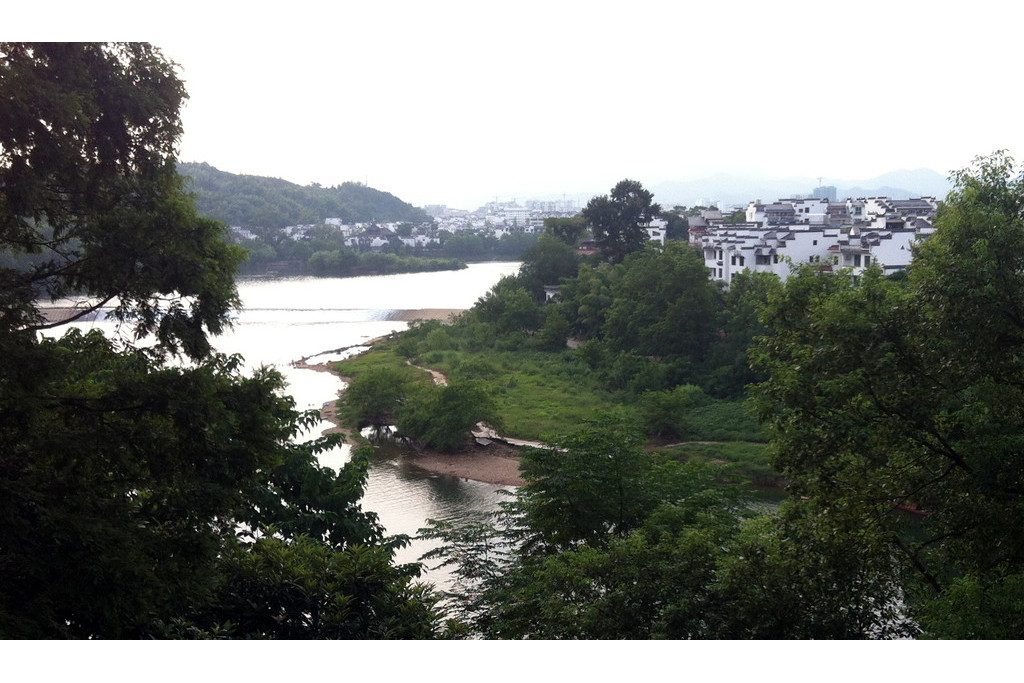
xmin=689 ymin=197 xmax=938 ymax=285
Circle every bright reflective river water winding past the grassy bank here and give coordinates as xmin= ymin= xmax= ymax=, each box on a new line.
xmin=48 ymin=262 xmax=519 ymax=585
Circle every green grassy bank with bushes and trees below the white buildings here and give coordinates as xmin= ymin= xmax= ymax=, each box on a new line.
xmin=337 ymin=233 xmax=778 ymax=485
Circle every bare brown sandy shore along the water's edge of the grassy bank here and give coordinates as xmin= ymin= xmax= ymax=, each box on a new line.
xmin=292 ymin=342 xmax=525 ymax=486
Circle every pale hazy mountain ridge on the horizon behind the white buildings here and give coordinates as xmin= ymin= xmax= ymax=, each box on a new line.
xmin=648 ymin=169 xmax=950 ymax=209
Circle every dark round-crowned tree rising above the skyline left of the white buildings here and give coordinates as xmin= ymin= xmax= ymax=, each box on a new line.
xmin=583 ymin=179 xmax=662 ymax=263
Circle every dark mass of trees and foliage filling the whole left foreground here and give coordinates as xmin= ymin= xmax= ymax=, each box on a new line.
xmin=0 ymin=43 xmax=434 ymax=638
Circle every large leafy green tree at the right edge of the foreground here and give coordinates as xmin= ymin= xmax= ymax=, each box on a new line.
xmin=758 ymin=153 xmax=1024 ymax=637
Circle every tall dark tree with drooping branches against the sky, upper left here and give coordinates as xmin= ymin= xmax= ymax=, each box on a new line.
xmin=0 ymin=43 xmax=243 ymax=357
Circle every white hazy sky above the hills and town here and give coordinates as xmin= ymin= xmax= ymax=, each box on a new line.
xmin=12 ymin=0 xmax=1024 ymax=209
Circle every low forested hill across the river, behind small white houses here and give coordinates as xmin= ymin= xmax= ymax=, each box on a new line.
xmin=178 ymin=163 xmax=430 ymax=228
